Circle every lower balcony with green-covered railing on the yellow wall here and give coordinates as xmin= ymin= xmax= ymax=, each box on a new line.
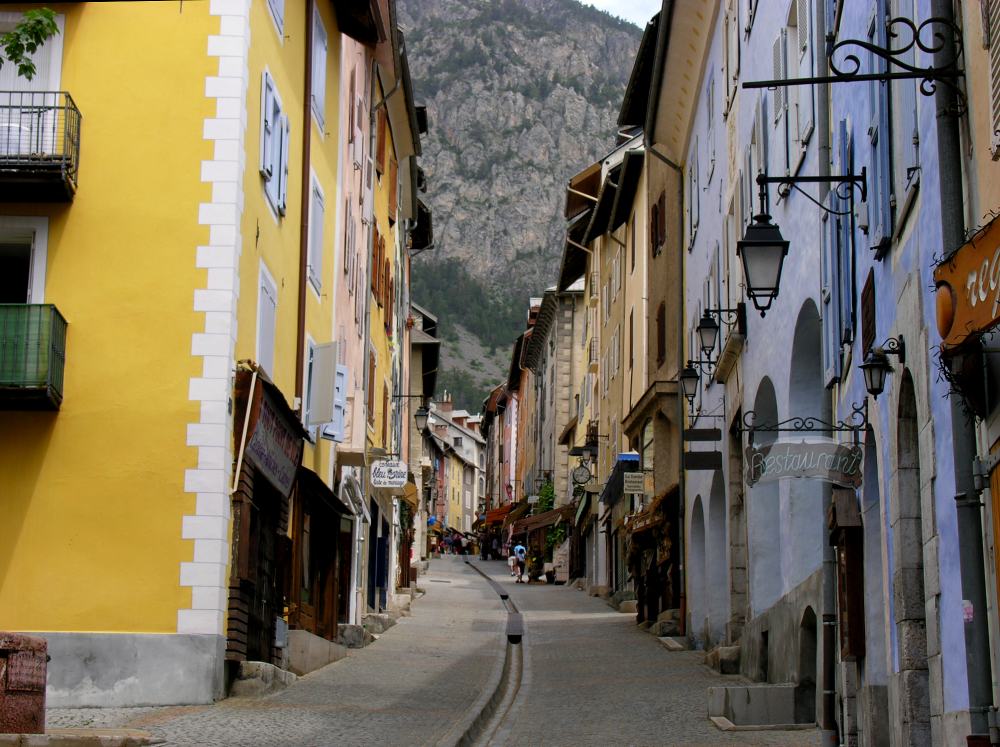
xmin=0 ymin=303 xmax=66 ymax=410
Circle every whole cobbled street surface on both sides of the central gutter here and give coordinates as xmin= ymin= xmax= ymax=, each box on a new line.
xmin=47 ymin=557 xmax=819 ymax=747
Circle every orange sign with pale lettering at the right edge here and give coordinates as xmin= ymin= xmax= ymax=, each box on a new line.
xmin=934 ymin=220 xmax=1000 ymax=350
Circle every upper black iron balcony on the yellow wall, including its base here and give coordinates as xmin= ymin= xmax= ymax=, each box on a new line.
xmin=0 ymin=91 xmax=81 ymax=202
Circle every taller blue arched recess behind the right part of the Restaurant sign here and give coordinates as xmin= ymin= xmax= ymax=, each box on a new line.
xmin=781 ymin=300 xmax=830 ymax=591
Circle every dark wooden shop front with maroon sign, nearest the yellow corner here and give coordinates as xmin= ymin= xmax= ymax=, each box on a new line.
xmin=226 ymin=365 xmax=305 ymax=664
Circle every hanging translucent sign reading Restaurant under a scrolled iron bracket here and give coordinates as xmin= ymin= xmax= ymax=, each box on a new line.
xmin=746 ymin=440 xmax=864 ymax=488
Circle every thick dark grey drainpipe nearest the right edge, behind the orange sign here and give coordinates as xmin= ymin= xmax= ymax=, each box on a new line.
xmin=931 ymin=0 xmax=993 ymax=735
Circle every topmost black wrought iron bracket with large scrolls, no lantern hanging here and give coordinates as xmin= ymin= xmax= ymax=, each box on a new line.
xmin=743 ymin=17 xmax=966 ymax=114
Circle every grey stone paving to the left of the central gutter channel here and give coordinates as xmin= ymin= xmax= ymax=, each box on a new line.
xmin=46 ymin=558 xmax=506 ymax=747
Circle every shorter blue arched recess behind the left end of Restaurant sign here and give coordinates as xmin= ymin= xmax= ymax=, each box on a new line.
xmin=747 ymin=376 xmax=782 ymax=615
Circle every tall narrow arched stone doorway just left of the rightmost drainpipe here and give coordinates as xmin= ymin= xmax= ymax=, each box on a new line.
xmin=890 ymin=370 xmax=931 ymax=745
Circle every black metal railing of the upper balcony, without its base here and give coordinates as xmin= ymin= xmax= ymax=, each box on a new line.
xmin=0 ymin=91 xmax=81 ymax=189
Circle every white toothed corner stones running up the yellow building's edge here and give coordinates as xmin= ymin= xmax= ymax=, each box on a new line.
xmin=183 ymin=0 xmax=254 ymax=635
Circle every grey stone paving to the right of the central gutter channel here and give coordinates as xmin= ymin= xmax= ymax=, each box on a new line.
xmin=476 ymin=561 xmax=820 ymax=747
